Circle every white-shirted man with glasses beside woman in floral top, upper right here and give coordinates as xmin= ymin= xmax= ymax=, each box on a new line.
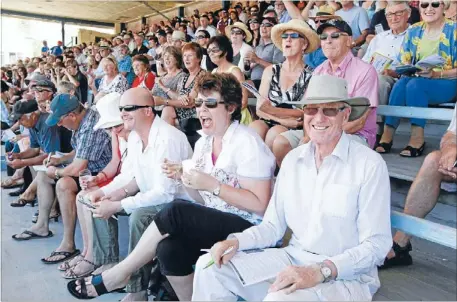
xmin=362 ymin=1 xmax=411 ymax=105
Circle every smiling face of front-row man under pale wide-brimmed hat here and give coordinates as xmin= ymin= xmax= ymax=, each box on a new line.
xmin=303 ymin=102 xmax=351 ymax=145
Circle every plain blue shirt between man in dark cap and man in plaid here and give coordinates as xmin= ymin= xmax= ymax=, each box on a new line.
xmin=29 ymin=112 xmax=61 ymax=153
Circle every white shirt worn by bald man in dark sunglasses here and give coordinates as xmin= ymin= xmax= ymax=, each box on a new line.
xmin=102 ymin=116 xmax=192 ymax=213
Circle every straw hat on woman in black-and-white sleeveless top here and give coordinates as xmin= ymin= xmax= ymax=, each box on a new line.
xmin=271 ymin=19 xmax=321 ymax=53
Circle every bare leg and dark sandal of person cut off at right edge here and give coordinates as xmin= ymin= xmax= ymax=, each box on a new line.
xmin=380 ymin=107 xmax=457 ymax=268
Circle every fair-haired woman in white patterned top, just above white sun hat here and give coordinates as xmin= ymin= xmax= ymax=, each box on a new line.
xmin=89 ymin=57 xmax=129 ymax=103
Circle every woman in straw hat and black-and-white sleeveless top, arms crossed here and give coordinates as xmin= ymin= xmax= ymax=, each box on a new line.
xmin=250 ymin=19 xmax=320 ymax=149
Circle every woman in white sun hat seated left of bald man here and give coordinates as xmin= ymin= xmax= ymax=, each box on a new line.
xmin=57 ymin=92 xmax=131 ymax=279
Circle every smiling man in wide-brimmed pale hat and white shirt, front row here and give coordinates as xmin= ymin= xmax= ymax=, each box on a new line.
xmin=192 ymin=75 xmax=392 ymax=301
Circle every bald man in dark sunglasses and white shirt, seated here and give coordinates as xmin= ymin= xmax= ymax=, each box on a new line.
xmin=84 ymin=88 xmax=192 ymax=301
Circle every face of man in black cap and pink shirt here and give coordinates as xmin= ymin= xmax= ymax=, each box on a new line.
xmin=321 ymin=27 xmax=352 ymax=60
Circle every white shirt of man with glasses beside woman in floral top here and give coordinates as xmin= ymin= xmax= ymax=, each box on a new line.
xmin=362 ymin=30 xmax=408 ymax=69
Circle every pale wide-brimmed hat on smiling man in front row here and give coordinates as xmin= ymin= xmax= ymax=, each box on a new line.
xmin=286 ymin=75 xmax=370 ymax=121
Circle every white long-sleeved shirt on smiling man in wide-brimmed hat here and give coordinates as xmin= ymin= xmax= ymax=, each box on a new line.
xmin=231 ymin=133 xmax=392 ymax=295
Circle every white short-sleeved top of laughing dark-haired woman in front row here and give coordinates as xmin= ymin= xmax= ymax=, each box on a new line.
xmin=192 ymin=122 xmax=276 ymax=224
